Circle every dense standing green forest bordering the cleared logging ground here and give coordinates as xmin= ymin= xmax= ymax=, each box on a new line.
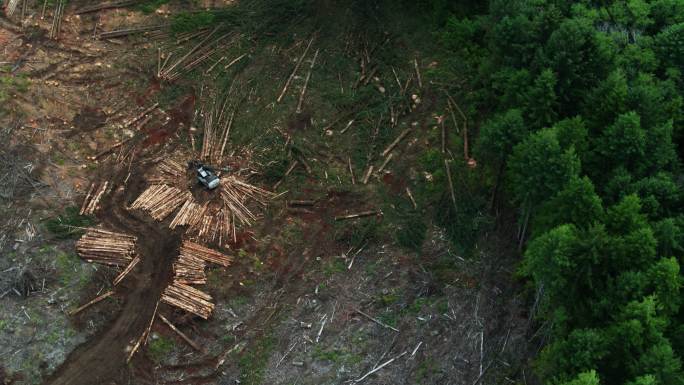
xmin=432 ymin=0 xmax=684 ymax=385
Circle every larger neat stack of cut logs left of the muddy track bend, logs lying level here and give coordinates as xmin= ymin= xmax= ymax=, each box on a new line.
xmin=76 ymin=228 xmax=136 ymax=266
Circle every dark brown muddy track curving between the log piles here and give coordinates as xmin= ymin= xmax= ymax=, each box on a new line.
xmin=45 ymin=164 xmax=180 ymax=385
